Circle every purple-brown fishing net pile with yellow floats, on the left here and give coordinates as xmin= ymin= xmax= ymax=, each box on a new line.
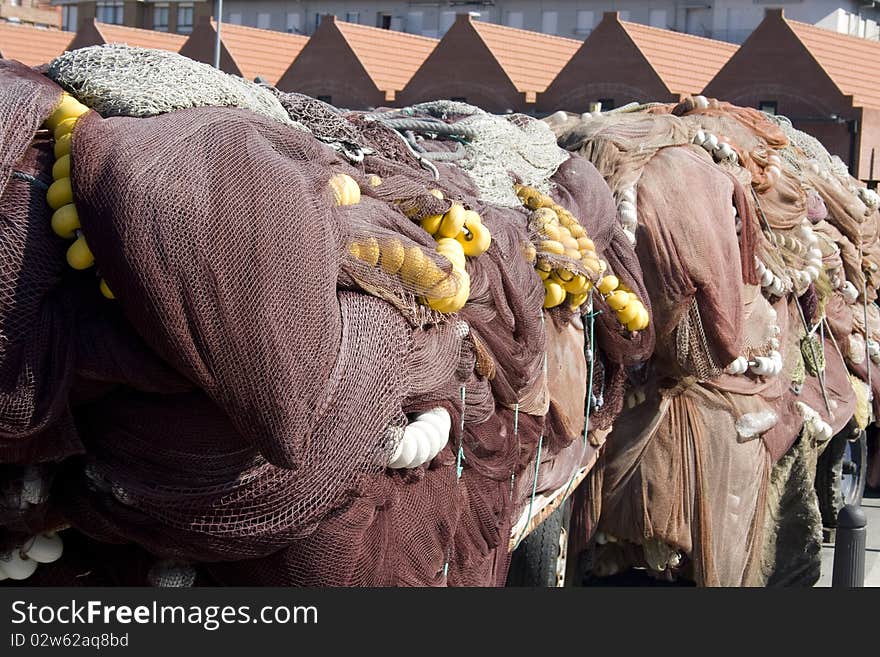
xmin=0 ymin=46 xmax=654 ymax=586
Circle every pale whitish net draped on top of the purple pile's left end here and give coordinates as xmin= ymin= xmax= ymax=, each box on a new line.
xmin=47 ymin=44 xmax=305 ymax=130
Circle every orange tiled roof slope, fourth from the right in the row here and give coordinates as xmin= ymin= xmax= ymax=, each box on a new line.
xmin=334 ymin=21 xmax=438 ymax=94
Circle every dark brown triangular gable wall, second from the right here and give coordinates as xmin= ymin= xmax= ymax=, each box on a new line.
xmin=537 ymin=15 xmax=678 ymax=113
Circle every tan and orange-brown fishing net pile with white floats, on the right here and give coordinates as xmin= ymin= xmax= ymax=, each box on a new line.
xmin=547 ymin=96 xmax=880 ymax=585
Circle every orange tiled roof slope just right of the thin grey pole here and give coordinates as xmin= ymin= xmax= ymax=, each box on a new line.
xmin=211 ymin=21 xmax=309 ymax=84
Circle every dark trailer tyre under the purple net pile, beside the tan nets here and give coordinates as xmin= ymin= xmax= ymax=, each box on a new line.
xmin=507 ymin=500 xmax=571 ymax=587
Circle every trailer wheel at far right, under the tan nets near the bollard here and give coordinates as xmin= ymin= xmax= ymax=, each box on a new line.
xmin=816 ymin=429 xmax=868 ymax=527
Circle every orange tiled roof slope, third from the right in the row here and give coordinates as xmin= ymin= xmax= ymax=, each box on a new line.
xmin=471 ymin=21 xmax=581 ymax=100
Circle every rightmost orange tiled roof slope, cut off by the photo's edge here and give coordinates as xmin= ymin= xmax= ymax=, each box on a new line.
xmin=785 ymin=18 xmax=880 ymax=108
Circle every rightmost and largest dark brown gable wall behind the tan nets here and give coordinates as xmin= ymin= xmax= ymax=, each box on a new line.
xmin=703 ymin=10 xmax=860 ymax=178
